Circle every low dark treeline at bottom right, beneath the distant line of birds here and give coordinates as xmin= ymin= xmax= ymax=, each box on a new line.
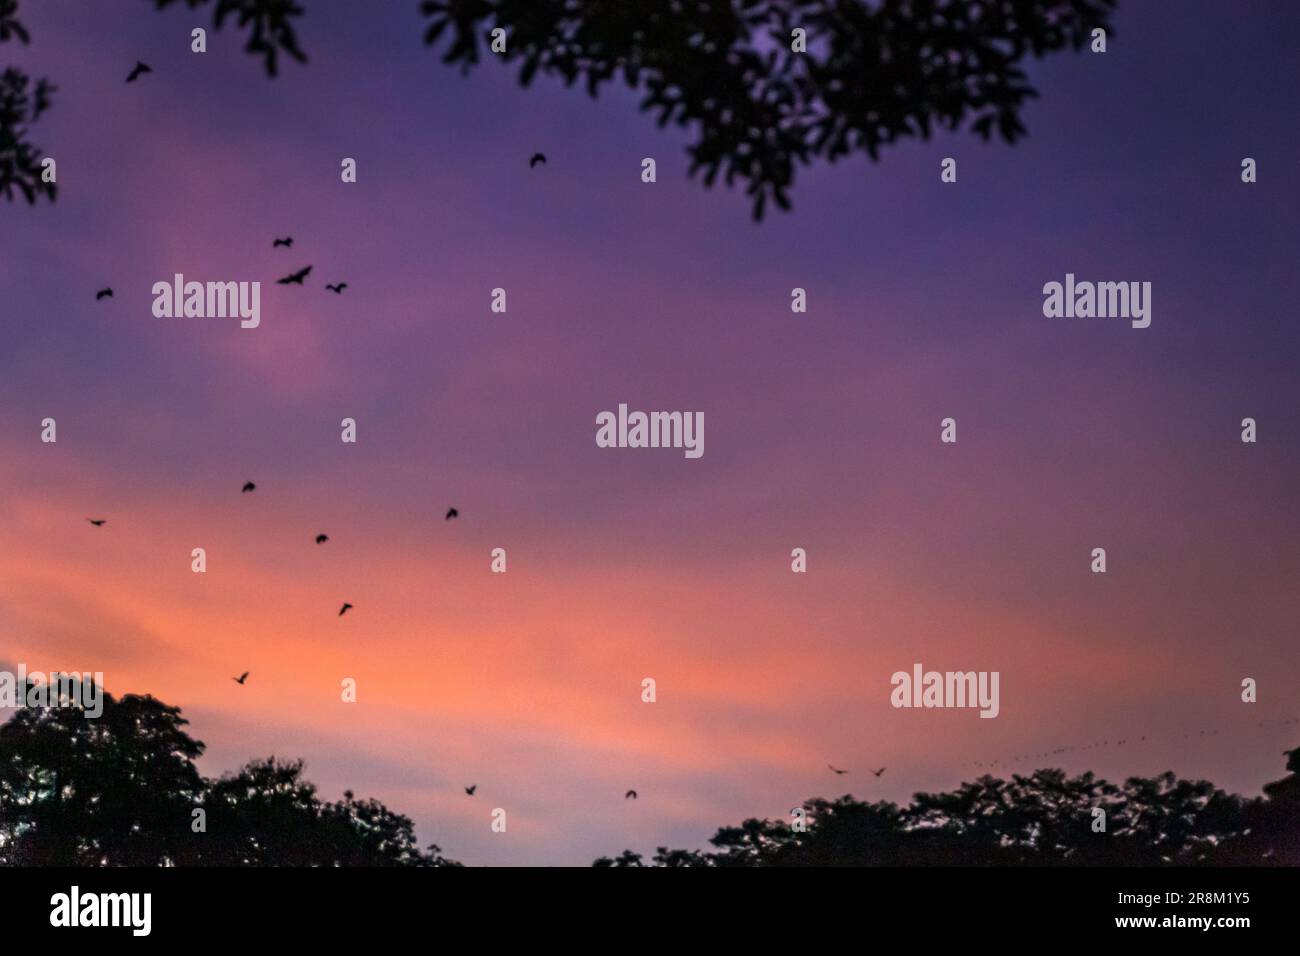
xmin=593 ymin=749 xmax=1300 ymax=866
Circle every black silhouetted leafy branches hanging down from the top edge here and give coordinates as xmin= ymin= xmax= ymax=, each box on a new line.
xmin=0 ymin=0 xmax=1115 ymax=219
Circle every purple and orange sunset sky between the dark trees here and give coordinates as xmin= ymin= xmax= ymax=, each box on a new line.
xmin=0 ymin=0 xmax=1300 ymax=865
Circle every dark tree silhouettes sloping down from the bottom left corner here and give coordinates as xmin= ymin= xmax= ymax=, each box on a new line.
xmin=0 ymin=693 xmax=459 ymax=866
